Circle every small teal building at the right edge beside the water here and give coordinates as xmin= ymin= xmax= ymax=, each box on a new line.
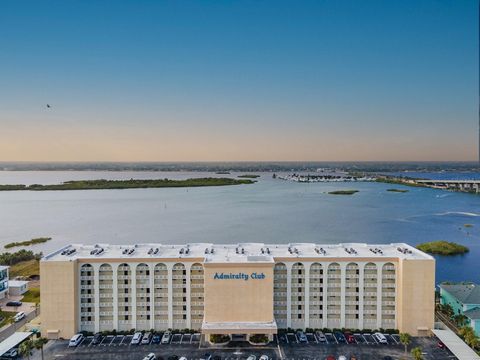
xmin=439 ymin=284 xmax=480 ymax=335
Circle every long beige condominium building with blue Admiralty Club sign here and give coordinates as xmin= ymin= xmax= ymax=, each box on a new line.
xmin=40 ymin=243 xmax=435 ymax=338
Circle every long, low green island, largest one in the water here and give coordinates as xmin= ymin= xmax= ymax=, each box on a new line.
xmin=0 ymin=177 xmax=255 ymax=191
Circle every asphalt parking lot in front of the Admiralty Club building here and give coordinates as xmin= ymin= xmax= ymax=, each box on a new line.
xmin=40 ymin=333 xmax=455 ymax=360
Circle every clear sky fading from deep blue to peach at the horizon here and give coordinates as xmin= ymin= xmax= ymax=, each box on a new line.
xmin=0 ymin=0 xmax=479 ymax=161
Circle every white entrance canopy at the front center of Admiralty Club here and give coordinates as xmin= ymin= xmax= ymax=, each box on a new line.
xmin=202 ymin=320 xmax=277 ymax=334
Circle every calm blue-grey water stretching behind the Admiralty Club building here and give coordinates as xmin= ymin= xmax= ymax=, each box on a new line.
xmin=0 ymin=171 xmax=480 ymax=282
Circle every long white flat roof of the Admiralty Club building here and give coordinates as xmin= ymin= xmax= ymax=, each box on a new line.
xmin=42 ymin=242 xmax=433 ymax=263
